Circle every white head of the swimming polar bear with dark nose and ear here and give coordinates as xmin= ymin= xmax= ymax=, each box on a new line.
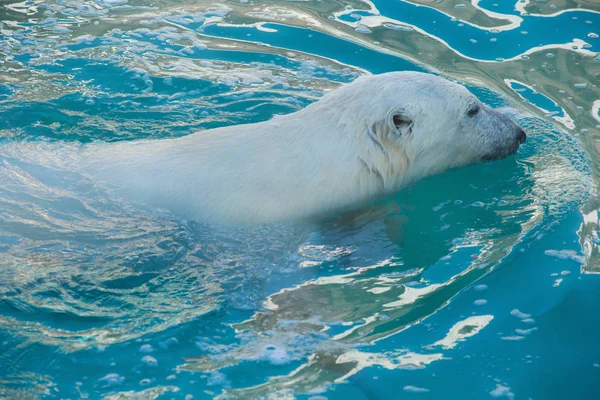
xmin=317 ymin=72 xmax=526 ymax=191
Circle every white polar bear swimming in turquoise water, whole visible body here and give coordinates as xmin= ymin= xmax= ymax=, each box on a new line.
xmin=79 ymin=72 xmax=526 ymax=224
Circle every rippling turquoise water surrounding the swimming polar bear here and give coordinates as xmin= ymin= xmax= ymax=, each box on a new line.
xmin=0 ymin=0 xmax=600 ymax=400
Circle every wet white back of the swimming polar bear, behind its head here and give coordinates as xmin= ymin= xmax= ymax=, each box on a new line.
xmin=82 ymin=114 xmax=380 ymax=223
